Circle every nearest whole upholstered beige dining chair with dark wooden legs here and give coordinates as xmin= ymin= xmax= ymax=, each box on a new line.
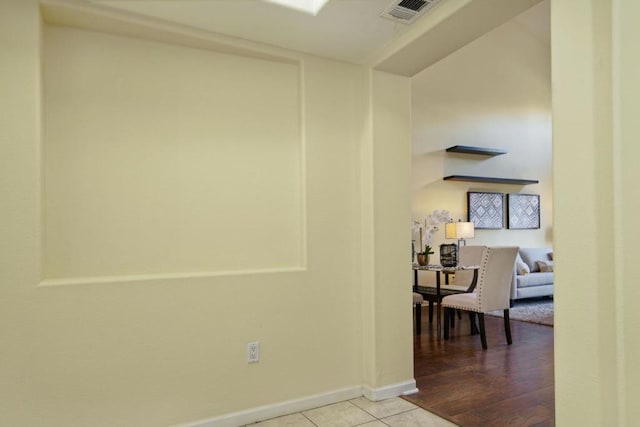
xmin=442 ymin=246 xmax=518 ymax=350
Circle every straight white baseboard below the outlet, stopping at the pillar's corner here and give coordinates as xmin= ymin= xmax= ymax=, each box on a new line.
xmin=175 ymin=388 xmax=362 ymax=427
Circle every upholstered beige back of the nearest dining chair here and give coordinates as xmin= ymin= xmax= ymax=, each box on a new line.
xmin=476 ymin=246 xmax=518 ymax=313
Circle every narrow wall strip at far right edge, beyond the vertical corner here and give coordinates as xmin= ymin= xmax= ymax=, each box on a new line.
xmin=616 ymin=1 xmax=640 ymax=425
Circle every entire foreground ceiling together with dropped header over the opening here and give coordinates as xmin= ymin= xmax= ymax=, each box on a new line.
xmin=75 ymin=0 xmax=550 ymax=72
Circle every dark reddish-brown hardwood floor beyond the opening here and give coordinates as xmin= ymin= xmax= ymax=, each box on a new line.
xmin=405 ymin=310 xmax=555 ymax=427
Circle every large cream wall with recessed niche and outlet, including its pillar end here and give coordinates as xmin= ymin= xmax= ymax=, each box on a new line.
xmin=0 ymin=0 xmax=413 ymax=426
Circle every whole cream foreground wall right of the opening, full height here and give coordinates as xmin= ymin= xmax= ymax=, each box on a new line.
xmin=552 ymin=0 xmax=640 ymax=426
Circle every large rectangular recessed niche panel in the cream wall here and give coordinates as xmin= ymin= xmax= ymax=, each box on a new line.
xmin=43 ymin=26 xmax=303 ymax=279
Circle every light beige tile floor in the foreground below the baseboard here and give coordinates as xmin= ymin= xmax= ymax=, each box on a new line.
xmin=242 ymin=397 xmax=455 ymax=427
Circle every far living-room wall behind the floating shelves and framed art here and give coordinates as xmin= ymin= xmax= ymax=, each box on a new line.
xmin=411 ymin=2 xmax=553 ymax=255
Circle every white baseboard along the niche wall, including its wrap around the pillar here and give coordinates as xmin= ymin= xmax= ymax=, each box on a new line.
xmin=176 ymin=380 xmax=418 ymax=427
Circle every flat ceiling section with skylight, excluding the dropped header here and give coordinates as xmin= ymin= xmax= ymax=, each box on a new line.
xmin=90 ymin=0 xmax=420 ymax=63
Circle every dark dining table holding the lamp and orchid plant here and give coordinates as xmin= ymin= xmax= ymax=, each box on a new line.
xmin=413 ymin=263 xmax=480 ymax=340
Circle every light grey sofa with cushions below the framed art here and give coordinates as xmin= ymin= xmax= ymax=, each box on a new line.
xmin=511 ymin=248 xmax=553 ymax=303
